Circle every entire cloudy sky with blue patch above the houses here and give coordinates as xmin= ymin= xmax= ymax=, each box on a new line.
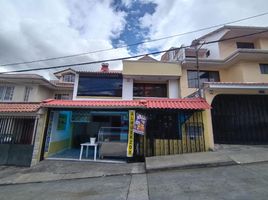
xmin=0 ymin=0 xmax=268 ymax=79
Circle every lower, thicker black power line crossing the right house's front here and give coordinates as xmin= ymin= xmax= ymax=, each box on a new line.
xmin=0 ymin=30 xmax=268 ymax=74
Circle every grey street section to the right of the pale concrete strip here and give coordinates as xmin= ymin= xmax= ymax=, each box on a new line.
xmin=147 ymin=163 xmax=268 ymax=200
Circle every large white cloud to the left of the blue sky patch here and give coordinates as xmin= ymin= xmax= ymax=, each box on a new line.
xmin=0 ymin=0 xmax=129 ymax=77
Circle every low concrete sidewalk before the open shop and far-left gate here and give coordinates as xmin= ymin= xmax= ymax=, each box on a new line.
xmin=0 ymin=160 xmax=145 ymax=185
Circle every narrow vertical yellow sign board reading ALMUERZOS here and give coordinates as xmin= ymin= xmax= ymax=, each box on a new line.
xmin=127 ymin=110 xmax=135 ymax=157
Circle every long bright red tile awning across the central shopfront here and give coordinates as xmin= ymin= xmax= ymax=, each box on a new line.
xmin=43 ymin=98 xmax=210 ymax=110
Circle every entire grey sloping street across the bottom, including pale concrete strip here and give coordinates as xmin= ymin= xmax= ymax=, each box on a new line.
xmin=0 ymin=163 xmax=268 ymax=200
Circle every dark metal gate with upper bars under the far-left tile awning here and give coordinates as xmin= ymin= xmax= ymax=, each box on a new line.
xmin=0 ymin=116 xmax=36 ymax=166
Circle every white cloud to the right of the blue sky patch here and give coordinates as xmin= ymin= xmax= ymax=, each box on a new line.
xmin=139 ymin=0 xmax=268 ymax=56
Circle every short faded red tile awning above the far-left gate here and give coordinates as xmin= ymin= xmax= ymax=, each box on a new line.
xmin=0 ymin=103 xmax=41 ymax=113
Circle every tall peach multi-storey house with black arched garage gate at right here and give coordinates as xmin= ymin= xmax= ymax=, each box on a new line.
xmin=162 ymin=26 xmax=268 ymax=144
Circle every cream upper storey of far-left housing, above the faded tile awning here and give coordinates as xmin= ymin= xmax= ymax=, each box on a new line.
xmin=0 ymin=70 xmax=74 ymax=102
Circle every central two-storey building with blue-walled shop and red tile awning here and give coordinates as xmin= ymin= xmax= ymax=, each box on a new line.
xmin=41 ymin=60 xmax=210 ymax=160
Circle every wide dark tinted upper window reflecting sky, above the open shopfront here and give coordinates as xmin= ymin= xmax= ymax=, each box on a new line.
xmin=77 ymin=74 xmax=122 ymax=97
